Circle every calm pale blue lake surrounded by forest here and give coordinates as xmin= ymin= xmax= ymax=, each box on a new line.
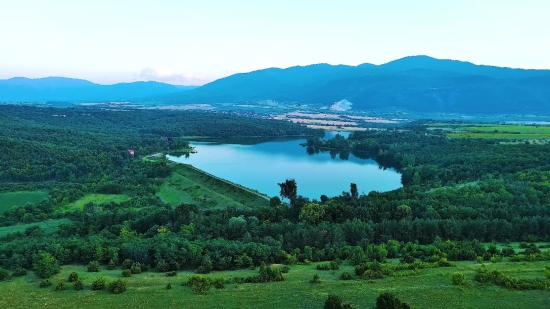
xmin=167 ymin=132 xmax=401 ymax=200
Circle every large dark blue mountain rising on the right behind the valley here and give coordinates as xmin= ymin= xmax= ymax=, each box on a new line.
xmin=154 ymin=56 xmax=550 ymax=114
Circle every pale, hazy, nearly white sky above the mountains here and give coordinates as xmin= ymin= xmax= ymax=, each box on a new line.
xmin=0 ymin=0 xmax=550 ymax=85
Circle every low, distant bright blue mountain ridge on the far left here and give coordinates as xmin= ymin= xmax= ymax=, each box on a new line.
xmin=0 ymin=77 xmax=196 ymax=102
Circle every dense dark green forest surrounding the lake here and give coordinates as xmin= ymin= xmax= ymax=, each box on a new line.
xmin=0 ymin=106 xmax=550 ymax=304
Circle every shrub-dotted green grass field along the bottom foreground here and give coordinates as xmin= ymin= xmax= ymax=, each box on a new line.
xmin=0 ymin=262 xmax=550 ymax=309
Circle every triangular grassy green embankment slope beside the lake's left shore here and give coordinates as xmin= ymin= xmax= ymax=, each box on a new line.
xmin=157 ymin=164 xmax=269 ymax=208
